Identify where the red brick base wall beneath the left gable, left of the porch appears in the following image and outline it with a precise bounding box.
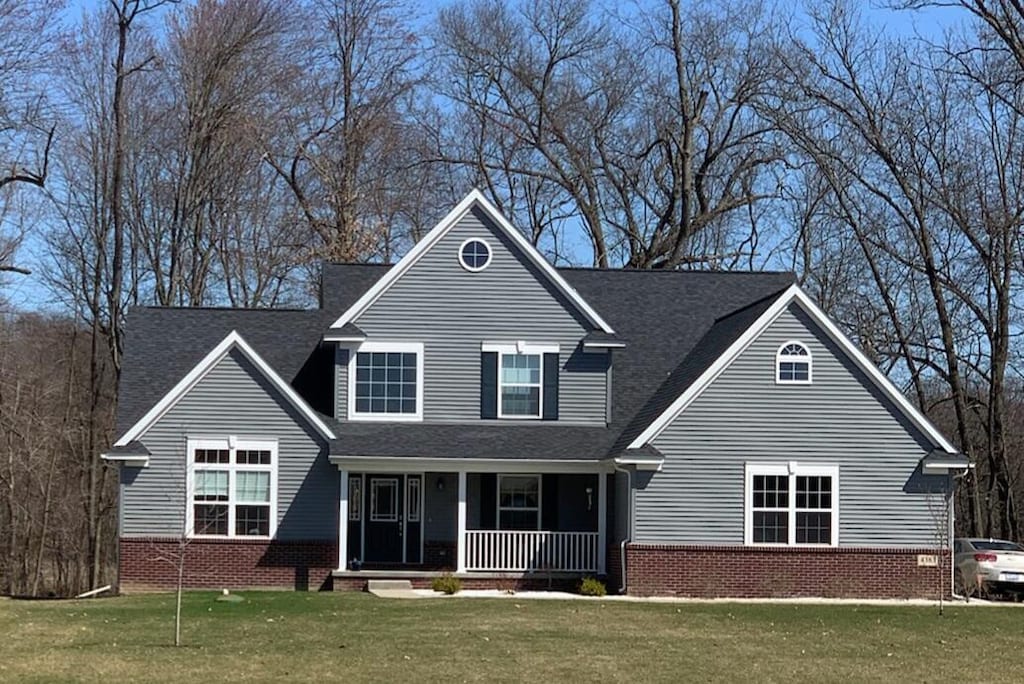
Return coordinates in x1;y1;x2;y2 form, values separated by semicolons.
119;538;338;592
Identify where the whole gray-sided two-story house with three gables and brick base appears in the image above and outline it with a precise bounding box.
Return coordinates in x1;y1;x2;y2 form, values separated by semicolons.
103;191;967;596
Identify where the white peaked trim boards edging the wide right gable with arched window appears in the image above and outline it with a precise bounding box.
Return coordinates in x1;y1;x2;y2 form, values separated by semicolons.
627;285;958;454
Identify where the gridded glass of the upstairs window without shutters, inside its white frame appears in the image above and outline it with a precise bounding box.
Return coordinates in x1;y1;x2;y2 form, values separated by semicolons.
355;351;417;414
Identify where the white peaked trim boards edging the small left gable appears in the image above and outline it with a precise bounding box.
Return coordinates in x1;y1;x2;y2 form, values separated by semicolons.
114;330;335;446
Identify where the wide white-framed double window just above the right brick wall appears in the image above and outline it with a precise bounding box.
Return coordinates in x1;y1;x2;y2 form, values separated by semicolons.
743;461;839;546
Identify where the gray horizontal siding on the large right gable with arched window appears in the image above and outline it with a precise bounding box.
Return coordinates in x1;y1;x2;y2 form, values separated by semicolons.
635;305;938;547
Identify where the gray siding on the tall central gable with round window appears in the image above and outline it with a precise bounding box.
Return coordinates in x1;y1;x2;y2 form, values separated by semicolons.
336;205;608;424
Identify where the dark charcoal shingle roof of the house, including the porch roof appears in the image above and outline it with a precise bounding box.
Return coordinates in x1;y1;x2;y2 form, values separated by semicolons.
118;263;794;459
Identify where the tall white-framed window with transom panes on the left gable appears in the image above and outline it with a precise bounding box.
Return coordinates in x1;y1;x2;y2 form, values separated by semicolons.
186;437;278;539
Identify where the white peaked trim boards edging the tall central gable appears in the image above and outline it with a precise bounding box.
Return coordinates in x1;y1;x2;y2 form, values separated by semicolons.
331;188;615;333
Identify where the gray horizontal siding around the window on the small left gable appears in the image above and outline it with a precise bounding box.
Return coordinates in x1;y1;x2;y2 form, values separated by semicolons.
121;350;340;541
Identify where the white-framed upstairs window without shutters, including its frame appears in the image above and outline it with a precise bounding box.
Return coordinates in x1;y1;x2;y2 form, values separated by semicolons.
348;342;423;421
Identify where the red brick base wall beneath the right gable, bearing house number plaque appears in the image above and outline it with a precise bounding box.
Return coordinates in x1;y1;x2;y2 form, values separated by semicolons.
622;544;949;598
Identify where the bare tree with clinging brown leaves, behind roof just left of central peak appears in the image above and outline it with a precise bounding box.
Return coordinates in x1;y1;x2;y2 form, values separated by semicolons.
265;0;422;261
